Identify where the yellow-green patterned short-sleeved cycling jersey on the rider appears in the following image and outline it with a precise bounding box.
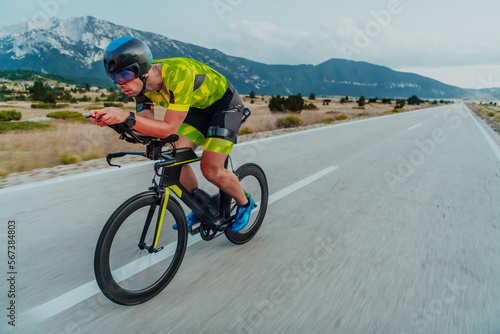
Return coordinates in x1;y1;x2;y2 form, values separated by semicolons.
142;58;228;112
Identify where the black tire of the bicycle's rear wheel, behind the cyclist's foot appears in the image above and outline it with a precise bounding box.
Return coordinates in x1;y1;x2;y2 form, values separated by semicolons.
224;163;269;245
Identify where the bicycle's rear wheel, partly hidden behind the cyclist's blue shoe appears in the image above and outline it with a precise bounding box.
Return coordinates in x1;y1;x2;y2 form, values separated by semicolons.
224;163;269;245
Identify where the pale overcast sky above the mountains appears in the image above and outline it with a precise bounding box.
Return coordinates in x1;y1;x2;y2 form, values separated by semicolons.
0;0;500;88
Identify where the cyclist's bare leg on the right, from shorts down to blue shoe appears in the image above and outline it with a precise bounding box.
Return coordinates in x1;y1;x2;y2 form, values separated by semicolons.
200;151;248;205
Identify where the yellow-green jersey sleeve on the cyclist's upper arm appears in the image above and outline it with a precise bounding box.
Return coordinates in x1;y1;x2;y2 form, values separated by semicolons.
162;63;196;111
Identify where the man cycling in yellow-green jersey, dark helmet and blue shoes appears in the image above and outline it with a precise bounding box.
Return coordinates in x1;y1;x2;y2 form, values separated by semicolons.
90;36;254;232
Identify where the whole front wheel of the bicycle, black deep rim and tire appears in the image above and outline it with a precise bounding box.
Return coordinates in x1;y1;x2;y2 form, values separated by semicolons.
94;191;187;305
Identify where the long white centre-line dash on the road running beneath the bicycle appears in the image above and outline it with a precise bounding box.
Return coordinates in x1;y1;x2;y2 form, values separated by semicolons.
23;166;338;324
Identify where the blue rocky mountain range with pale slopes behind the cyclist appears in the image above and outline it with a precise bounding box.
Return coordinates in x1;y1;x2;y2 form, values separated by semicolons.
0;16;494;99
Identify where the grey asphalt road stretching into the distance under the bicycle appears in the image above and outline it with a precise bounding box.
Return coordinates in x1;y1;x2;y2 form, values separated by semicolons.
0;103;500;334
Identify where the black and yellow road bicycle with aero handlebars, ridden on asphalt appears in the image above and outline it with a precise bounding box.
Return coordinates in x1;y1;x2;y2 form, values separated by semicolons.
94;109;268;305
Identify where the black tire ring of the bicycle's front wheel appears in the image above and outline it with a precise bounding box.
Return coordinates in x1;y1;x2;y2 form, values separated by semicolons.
94;191;188;306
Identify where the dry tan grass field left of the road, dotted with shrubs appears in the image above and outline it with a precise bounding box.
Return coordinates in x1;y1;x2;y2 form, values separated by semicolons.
0;93;444;177
